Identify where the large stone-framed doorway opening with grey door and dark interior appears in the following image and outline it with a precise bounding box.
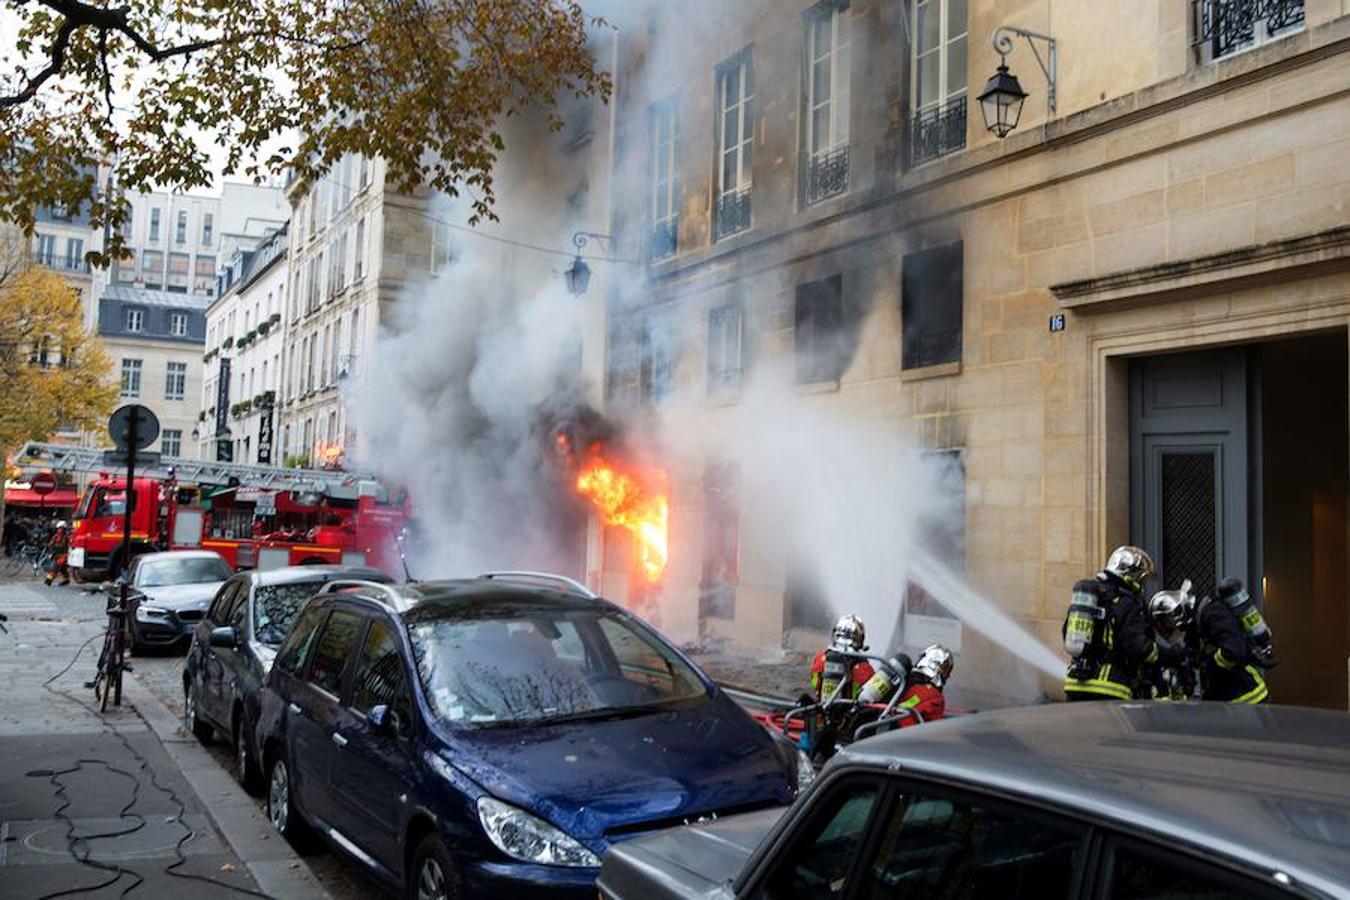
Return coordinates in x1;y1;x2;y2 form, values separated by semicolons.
1130;331;1350;710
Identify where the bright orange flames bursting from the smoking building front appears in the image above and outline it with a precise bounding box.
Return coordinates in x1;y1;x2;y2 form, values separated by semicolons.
576;453;670;583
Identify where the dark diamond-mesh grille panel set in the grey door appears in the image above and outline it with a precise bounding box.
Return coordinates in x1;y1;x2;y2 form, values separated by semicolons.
1161;453;1219;596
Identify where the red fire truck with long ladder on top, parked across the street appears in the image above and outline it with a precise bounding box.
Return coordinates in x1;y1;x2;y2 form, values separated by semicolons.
16;443;409;582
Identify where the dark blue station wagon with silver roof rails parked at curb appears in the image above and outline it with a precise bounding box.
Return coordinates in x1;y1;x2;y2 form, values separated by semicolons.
258;573;811;900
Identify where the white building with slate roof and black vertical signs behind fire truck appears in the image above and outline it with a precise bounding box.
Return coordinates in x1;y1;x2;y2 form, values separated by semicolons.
193;225;289;466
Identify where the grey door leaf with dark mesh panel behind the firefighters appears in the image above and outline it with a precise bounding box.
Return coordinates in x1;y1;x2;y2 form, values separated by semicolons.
1130;348;1251;594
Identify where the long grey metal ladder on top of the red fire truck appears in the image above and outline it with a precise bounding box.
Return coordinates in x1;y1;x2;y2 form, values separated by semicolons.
14;441;379;499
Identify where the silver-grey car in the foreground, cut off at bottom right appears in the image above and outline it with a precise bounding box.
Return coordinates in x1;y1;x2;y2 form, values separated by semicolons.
598;703;1350;900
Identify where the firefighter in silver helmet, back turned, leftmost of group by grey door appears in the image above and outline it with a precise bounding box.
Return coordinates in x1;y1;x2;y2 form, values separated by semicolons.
1064;546;1184;702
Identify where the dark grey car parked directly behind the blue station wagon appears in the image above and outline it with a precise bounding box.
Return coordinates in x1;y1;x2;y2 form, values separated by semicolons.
182;565;390;787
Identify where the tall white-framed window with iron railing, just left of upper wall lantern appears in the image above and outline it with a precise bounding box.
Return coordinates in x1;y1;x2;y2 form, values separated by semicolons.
909;0;968;165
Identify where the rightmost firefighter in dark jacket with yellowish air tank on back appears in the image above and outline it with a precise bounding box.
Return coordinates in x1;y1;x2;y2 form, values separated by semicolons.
1193;579;1273;703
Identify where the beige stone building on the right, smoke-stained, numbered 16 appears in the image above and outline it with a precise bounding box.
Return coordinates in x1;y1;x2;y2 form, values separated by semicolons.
599;0;1350;708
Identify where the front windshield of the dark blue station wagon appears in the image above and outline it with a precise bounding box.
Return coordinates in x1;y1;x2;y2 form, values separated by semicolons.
408;607;707;727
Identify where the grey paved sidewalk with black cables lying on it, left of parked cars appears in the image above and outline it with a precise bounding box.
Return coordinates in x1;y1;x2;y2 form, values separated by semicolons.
0;580;327;900
